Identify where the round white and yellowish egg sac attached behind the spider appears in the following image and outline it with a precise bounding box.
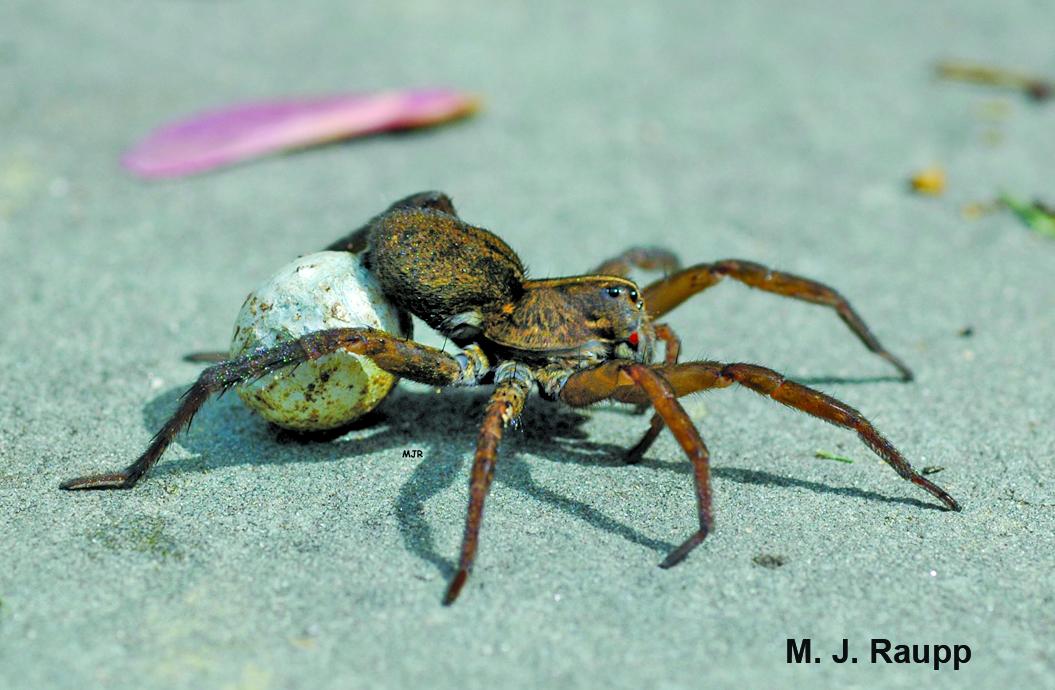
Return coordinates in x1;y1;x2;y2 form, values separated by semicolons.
231;251;410;430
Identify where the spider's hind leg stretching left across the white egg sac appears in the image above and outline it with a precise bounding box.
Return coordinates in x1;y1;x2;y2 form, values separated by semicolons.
61;328;487;490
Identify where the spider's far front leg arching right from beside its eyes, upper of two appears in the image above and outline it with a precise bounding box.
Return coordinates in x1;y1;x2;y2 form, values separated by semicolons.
642;260;913;381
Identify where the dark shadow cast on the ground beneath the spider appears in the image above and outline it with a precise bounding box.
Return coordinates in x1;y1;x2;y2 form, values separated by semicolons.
143;386;937;578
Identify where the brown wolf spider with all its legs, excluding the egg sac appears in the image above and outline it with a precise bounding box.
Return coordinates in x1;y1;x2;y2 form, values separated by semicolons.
62;192;960;605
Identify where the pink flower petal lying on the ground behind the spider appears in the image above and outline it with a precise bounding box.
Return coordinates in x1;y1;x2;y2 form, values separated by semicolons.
121;89;479;178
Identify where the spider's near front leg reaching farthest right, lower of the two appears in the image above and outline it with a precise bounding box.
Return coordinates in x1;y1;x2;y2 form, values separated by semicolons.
560;361;960;511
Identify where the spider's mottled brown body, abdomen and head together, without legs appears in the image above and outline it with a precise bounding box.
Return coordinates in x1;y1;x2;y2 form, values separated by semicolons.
366;208;652;368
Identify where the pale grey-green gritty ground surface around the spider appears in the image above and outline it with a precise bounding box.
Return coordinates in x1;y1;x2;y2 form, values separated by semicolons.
0;0;1055;689
